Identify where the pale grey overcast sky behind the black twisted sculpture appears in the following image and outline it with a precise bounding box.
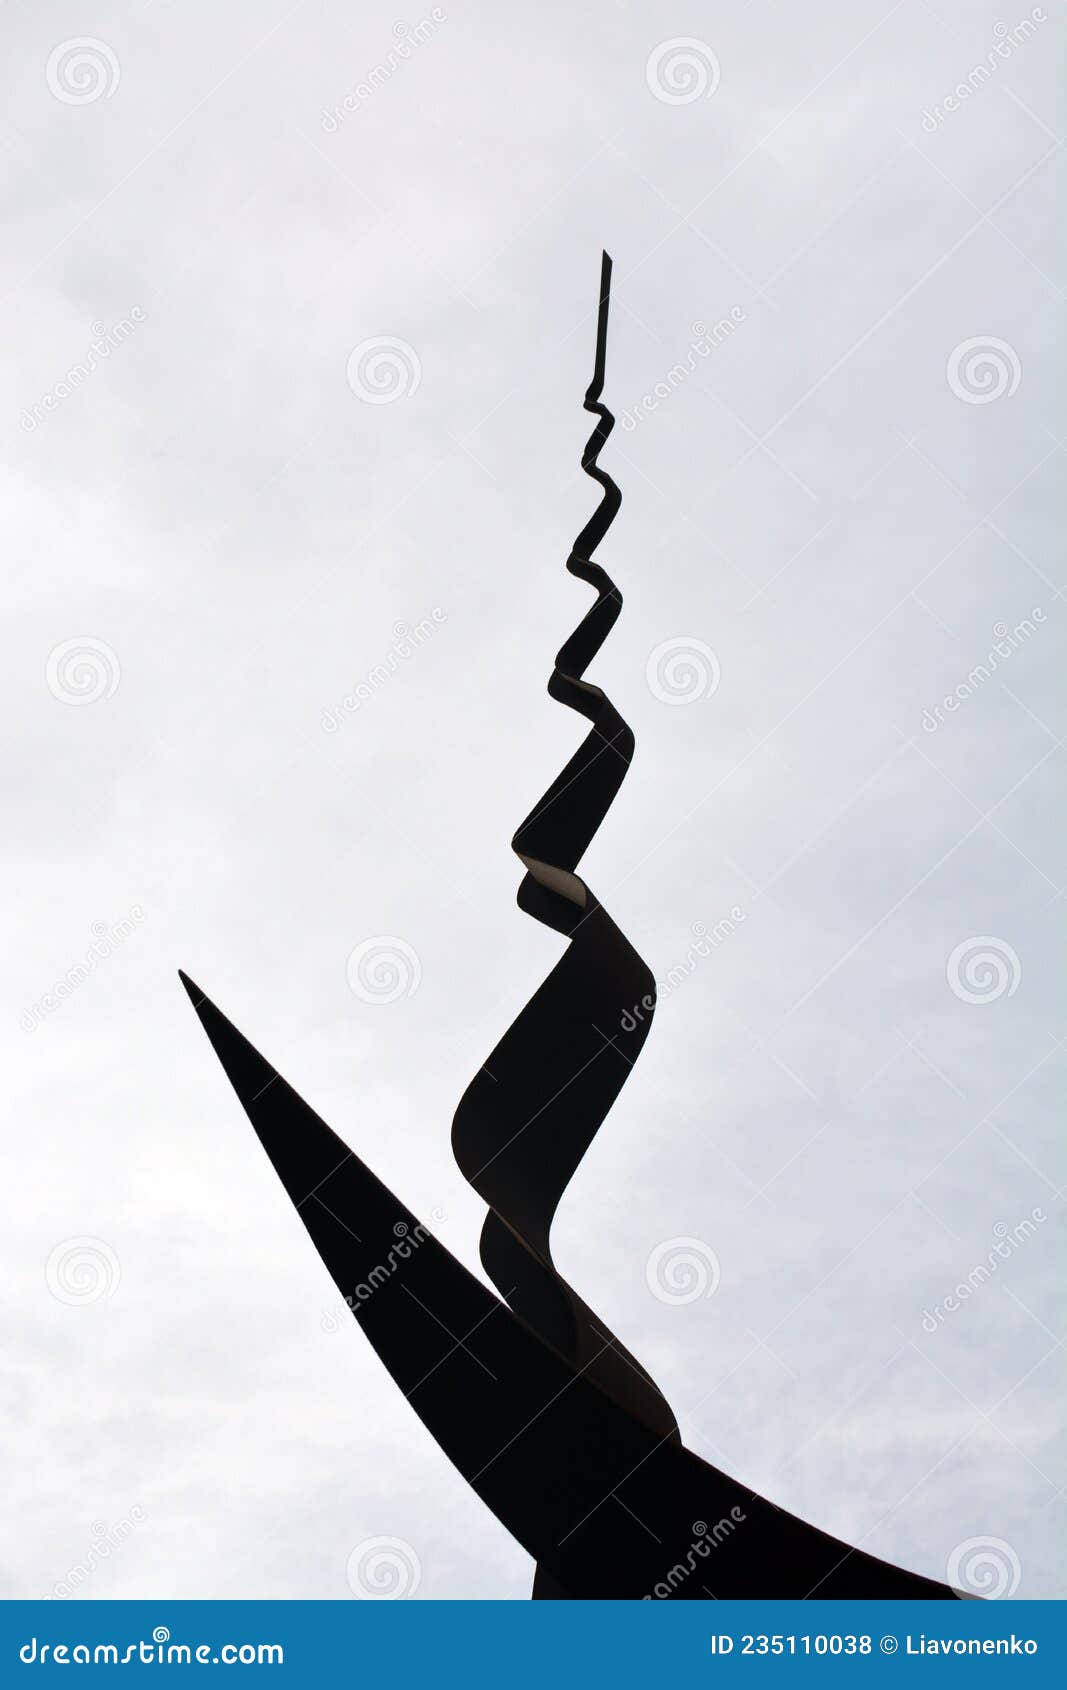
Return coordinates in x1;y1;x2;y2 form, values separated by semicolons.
0;0;1067;1599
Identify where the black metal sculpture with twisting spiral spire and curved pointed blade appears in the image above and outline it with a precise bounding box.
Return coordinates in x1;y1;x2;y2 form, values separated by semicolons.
181;254;955;1599
